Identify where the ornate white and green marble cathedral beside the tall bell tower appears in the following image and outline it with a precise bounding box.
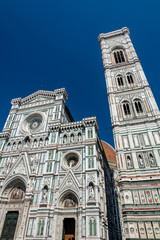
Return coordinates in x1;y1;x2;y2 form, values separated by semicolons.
0;89;120;240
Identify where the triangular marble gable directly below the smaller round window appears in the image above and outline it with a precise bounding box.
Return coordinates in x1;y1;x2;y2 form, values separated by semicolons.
59;169;81;194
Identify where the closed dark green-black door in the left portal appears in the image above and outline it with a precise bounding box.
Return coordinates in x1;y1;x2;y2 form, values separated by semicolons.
0;212;19;240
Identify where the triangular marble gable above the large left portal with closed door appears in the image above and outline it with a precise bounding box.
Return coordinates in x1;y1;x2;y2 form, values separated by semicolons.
6;153;30;179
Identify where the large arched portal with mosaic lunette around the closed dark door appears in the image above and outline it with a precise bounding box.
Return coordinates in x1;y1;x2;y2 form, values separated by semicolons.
0;179;26;240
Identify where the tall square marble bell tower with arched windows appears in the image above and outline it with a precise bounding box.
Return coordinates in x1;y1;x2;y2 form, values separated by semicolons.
98;27;160;239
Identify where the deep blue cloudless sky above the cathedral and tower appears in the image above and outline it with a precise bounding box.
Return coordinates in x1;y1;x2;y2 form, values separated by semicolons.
0;0;160;146
